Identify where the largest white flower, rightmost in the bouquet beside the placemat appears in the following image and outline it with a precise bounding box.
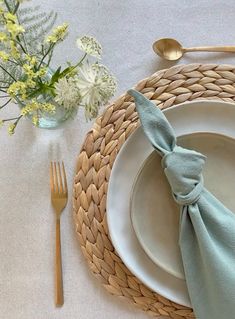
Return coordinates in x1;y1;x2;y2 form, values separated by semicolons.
76;63;117;119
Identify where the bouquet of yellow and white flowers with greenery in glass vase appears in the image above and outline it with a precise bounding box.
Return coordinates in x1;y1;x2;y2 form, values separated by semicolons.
0;0;116;134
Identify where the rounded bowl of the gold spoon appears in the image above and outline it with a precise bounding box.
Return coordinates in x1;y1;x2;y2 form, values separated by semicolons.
153;38;184;61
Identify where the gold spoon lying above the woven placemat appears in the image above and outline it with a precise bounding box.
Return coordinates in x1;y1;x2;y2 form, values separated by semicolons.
153;38;235;61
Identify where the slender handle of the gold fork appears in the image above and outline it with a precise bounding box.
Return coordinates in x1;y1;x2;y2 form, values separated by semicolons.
55;217;64;307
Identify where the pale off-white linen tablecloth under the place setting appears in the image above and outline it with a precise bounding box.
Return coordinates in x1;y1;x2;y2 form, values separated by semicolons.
0;0;235;319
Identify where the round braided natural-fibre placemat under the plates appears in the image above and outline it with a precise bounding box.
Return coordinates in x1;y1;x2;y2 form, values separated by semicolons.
73;64;235;319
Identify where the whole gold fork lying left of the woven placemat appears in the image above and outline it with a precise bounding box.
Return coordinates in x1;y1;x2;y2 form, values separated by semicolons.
50;162;68;307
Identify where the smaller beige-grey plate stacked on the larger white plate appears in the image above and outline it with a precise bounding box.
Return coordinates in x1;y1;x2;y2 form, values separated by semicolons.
130;133;235;279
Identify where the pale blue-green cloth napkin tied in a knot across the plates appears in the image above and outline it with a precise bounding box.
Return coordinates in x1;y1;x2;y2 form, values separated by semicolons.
128;90;235;319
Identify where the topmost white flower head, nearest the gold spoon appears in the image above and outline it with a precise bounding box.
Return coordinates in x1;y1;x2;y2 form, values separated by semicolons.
77;35;102;58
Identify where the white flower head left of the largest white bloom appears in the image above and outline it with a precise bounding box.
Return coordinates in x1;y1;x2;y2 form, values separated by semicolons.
55;77;80;109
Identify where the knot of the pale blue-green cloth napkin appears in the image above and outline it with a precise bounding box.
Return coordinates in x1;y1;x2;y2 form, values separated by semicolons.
162;146;205;205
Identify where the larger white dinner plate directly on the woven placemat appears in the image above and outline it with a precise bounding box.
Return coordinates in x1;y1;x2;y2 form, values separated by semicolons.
107;101;235;307
